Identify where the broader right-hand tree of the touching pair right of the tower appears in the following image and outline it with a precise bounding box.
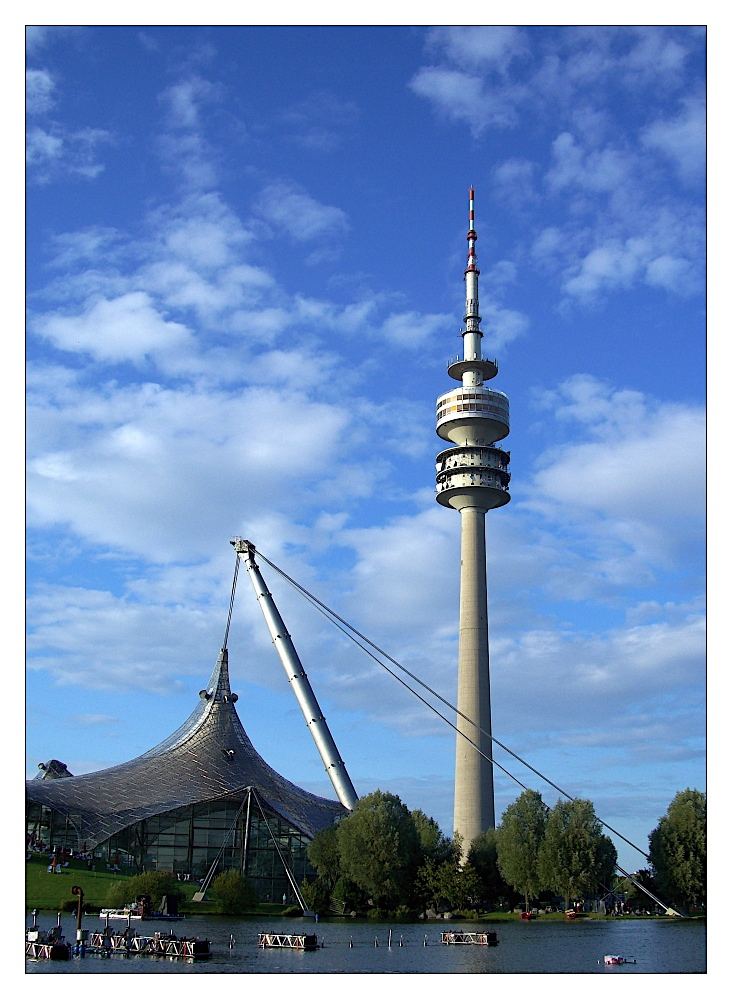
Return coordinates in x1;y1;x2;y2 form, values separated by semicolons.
536;799;617;906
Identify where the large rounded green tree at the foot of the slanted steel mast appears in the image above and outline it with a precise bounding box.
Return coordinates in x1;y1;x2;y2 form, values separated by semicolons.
336;791;420;909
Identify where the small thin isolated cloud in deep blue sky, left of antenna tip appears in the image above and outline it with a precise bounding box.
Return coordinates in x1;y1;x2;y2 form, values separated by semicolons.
255;182;348;243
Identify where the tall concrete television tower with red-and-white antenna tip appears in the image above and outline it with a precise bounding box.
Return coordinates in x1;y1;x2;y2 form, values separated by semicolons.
436;188;511;856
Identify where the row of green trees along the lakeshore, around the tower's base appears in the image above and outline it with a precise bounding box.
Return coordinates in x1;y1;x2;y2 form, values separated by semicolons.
302;789;706;917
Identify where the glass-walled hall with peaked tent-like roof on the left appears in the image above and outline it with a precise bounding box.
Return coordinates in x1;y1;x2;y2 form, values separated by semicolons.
26;649;346;902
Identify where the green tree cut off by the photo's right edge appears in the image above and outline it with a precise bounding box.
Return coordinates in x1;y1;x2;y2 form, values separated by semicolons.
648;788;707;909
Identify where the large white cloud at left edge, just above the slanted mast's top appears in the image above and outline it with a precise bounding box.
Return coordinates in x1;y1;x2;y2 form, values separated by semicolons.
29;370;362;561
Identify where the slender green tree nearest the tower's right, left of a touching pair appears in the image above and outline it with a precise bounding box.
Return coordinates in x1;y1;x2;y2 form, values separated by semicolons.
496;789;546;910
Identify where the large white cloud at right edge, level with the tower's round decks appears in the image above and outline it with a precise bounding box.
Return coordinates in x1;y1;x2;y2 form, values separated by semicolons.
526;376;706;575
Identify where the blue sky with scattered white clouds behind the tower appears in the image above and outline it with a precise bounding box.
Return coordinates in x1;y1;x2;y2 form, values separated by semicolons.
25;19;707;870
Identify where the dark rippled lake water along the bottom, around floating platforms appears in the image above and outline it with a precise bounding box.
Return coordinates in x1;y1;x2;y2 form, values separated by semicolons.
26;913;706;976
